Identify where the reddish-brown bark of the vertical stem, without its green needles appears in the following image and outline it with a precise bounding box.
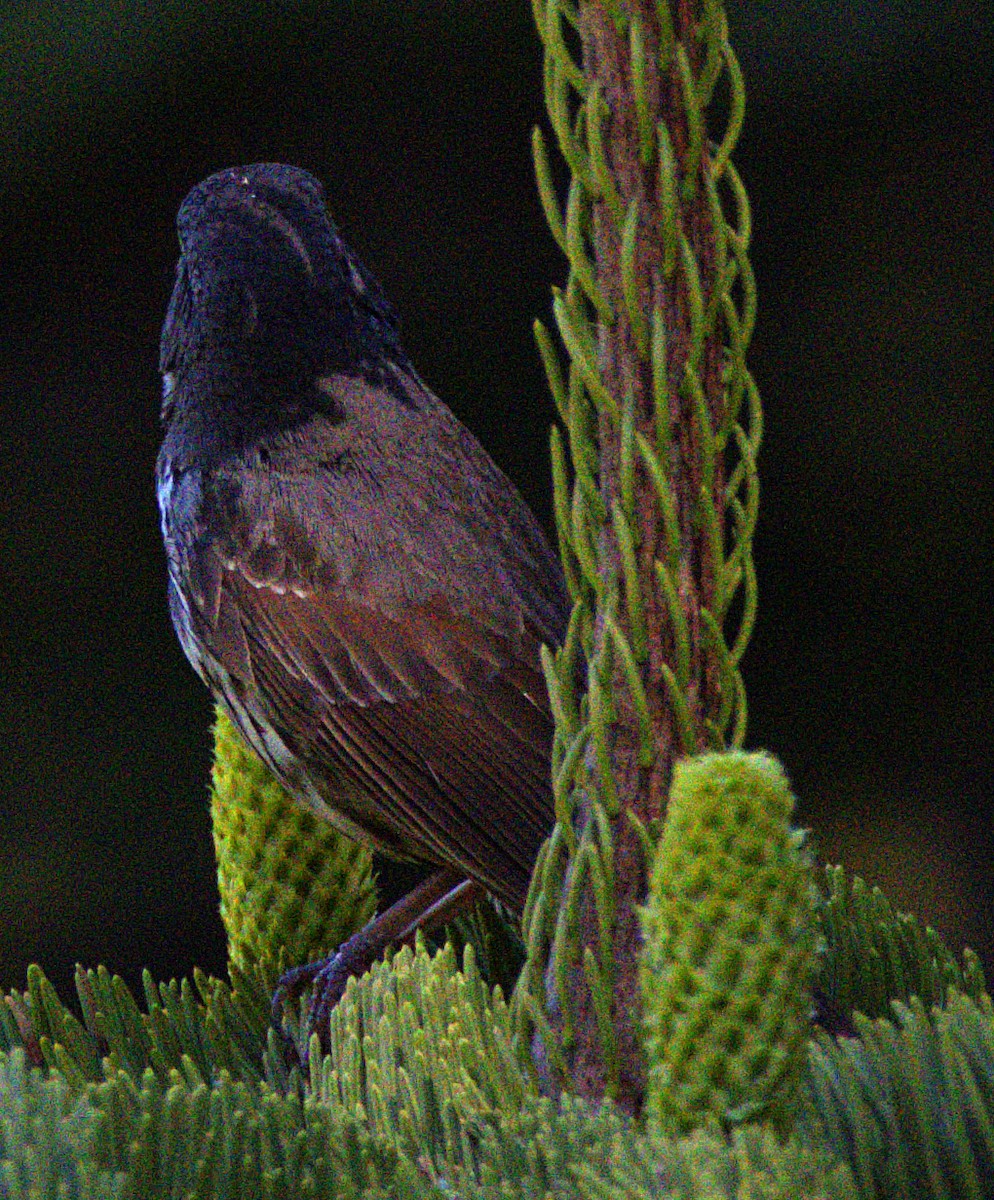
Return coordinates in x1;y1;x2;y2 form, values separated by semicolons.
561;0;724;1111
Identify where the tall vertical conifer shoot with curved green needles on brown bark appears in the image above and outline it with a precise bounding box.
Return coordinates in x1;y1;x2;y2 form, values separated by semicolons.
514;0;762;1111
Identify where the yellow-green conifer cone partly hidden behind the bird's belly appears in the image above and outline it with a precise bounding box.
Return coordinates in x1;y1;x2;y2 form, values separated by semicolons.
210;708;376;967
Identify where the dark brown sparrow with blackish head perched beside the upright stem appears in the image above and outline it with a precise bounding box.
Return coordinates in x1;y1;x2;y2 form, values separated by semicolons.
157;163;568;1036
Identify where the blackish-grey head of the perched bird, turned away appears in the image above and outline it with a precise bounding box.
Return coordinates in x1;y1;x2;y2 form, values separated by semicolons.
160;163;402;373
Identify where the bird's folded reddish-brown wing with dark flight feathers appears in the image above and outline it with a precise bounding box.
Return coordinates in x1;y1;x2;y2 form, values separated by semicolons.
180;525;552;910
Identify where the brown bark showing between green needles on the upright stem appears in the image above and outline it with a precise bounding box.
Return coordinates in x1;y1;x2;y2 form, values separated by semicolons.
549;0;724;1114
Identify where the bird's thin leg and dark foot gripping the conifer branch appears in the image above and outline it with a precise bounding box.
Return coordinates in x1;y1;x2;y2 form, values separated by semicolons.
271;868;486;1061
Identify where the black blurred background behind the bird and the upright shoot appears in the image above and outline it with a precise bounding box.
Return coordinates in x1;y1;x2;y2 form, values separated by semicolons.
0;0;994;989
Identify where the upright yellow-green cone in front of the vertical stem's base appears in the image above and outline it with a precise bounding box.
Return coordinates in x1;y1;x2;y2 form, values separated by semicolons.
641;751;816;1133
